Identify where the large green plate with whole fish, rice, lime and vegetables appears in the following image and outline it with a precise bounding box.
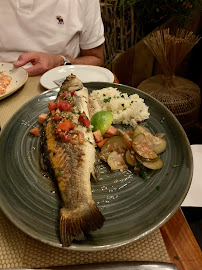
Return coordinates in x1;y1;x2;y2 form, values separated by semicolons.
0;75;193;251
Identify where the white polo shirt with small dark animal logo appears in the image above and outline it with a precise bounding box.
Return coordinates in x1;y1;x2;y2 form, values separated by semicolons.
0;0;105;62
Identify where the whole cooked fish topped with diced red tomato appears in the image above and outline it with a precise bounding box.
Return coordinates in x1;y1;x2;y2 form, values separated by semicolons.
41;75;104;246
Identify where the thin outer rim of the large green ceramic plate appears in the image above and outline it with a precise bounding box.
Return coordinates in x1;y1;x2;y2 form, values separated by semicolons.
0;82;193;251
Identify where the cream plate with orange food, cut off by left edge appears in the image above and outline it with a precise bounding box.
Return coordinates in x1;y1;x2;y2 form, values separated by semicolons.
0;62;28;100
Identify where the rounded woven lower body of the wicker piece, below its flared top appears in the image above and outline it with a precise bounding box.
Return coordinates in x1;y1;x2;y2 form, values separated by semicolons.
137;75;201;130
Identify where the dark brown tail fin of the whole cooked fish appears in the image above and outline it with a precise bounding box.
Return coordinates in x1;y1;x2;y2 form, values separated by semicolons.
60;200;105;247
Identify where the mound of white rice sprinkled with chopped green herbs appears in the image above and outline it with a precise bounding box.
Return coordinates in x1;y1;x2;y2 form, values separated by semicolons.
90;87;150;127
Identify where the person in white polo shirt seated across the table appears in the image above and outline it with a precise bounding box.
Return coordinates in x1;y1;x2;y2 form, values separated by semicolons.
0;0;105;76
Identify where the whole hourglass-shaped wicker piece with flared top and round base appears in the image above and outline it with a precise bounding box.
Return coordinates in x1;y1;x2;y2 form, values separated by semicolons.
137;29;201;129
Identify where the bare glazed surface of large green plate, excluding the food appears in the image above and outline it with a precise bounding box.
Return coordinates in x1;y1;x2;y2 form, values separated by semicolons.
0;82;193;250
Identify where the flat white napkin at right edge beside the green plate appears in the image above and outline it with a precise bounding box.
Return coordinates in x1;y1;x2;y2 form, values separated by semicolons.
181;144;202;207
